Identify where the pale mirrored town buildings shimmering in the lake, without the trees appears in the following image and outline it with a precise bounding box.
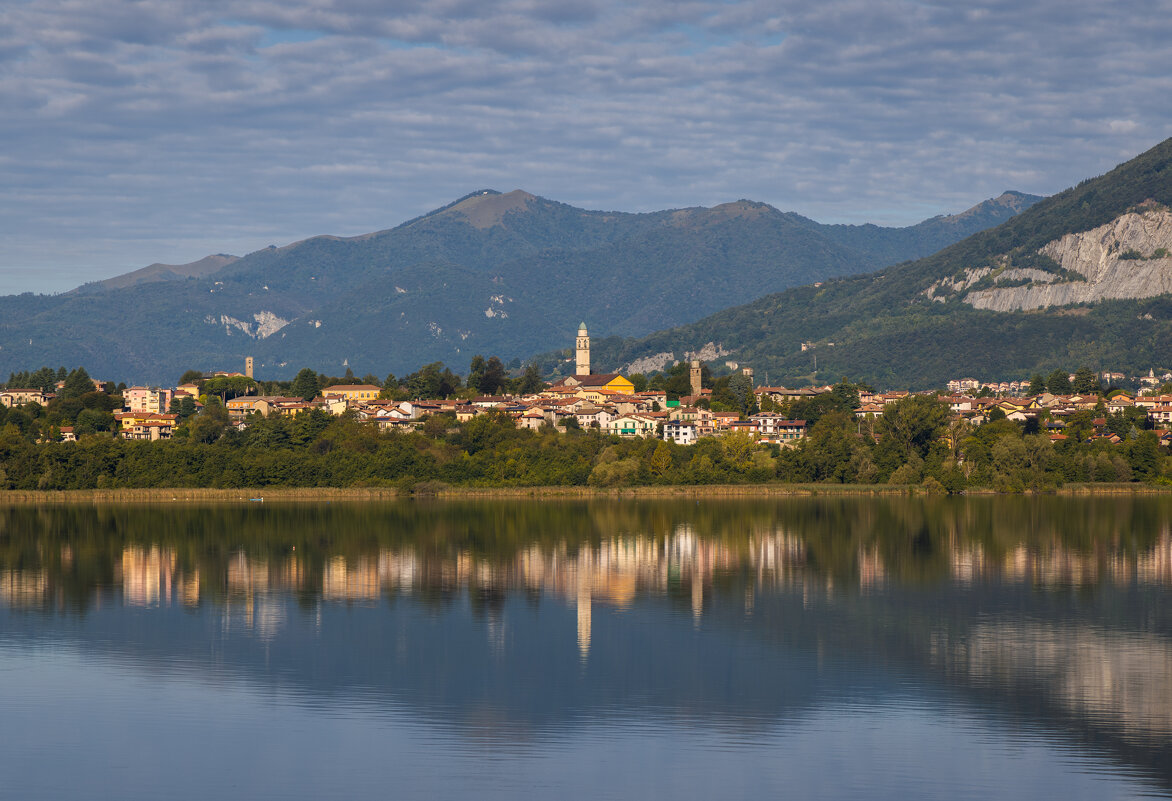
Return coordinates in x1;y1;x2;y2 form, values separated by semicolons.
0;524;1172;617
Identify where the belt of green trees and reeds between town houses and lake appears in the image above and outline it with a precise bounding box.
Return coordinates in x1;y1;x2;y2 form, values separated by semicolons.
0;375;1172;494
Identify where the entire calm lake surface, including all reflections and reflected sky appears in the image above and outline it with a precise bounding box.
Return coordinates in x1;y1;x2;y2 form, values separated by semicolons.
0;497;1172;800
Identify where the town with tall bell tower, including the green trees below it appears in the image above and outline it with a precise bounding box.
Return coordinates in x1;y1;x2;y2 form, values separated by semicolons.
0;324;1172;493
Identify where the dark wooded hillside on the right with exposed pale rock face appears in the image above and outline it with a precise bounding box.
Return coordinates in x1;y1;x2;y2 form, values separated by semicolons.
578;140;1172;388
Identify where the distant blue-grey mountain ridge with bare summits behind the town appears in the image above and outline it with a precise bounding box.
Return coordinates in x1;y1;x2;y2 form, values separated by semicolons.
0;190;1037;381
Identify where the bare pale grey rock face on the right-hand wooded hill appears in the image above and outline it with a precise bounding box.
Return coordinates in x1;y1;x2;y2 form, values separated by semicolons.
965;208;1172;312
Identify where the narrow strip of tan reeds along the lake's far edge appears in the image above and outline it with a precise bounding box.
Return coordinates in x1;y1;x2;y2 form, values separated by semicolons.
0;483;1172;508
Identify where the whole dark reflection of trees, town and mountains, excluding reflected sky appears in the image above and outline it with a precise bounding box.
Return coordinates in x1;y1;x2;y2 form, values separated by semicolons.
0;497;1172;794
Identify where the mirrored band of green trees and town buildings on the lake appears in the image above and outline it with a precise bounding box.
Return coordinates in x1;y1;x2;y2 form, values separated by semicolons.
0;498;1172;616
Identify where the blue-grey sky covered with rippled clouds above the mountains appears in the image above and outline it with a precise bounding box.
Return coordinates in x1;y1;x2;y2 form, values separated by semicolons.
0;0;1172;294
